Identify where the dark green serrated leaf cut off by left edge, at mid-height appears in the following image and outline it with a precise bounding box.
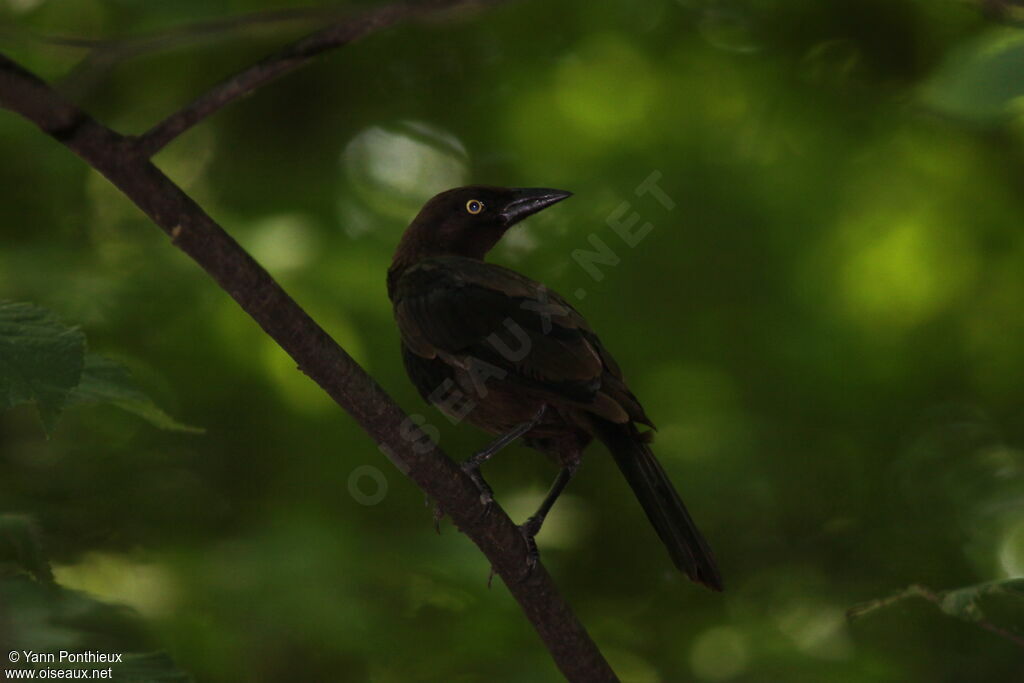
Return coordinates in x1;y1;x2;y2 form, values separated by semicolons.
0;302;85;436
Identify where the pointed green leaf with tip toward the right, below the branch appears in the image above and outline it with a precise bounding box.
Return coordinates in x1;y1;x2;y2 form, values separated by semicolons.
70;353;204;433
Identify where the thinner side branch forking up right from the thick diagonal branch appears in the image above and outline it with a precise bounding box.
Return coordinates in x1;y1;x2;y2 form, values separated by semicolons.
137;0;498;157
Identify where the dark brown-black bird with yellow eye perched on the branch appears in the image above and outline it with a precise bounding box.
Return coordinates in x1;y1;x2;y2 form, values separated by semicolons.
387;185;723;591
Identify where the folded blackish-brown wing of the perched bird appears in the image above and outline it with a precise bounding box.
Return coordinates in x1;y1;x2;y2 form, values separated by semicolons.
394;256;649;423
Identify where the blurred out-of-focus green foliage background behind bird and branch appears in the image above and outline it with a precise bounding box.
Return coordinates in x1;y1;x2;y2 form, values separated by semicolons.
0;0;1024;683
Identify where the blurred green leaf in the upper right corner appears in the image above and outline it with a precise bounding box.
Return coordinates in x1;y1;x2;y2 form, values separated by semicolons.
921;29;1024;124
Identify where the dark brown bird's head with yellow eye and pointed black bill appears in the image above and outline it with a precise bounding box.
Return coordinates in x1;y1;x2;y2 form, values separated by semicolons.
395;185;572;261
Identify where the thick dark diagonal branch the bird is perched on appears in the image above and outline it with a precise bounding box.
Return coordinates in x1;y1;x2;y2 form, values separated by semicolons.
0;52;617;683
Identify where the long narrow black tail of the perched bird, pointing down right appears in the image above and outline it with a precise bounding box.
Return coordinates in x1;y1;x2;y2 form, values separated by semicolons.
597;420;722;591
